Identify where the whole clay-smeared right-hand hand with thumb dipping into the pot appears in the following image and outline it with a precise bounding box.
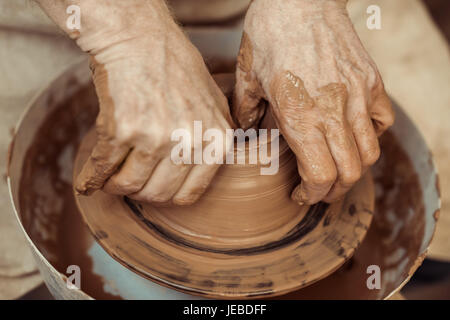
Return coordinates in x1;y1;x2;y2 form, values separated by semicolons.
233;0;394;204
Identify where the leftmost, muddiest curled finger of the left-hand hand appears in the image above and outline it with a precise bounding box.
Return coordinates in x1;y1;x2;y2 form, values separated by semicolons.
75;133;130;195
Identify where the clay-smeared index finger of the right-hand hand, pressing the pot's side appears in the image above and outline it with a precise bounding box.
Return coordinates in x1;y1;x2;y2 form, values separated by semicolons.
271;72;337;205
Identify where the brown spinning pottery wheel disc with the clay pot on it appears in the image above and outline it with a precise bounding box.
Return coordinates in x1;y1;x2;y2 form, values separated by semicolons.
74;124;374;298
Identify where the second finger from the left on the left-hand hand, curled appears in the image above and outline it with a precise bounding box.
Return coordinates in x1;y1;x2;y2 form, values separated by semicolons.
103;149;160;195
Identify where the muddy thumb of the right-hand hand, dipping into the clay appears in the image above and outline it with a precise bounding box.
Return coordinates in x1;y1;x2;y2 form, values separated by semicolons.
232;32;264;129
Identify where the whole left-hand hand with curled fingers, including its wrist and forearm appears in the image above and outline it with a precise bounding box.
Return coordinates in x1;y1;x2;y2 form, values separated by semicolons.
39;0;232;205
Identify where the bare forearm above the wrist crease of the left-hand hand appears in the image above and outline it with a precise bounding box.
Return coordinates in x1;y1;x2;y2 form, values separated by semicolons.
36;0;177;53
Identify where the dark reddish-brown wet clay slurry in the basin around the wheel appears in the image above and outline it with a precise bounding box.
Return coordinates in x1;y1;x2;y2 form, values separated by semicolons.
19;79;424;299
